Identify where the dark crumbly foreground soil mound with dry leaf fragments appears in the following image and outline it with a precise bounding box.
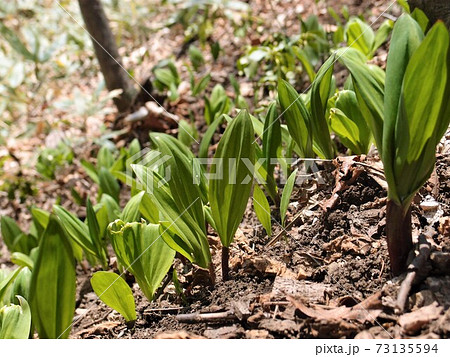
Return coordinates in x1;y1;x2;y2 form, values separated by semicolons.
72;158;450;338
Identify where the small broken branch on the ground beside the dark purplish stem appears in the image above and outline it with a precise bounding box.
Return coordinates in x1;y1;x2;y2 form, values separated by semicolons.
397;234;431;312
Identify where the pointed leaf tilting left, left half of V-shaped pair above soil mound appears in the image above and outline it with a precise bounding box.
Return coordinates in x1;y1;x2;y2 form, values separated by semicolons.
278;80;315;157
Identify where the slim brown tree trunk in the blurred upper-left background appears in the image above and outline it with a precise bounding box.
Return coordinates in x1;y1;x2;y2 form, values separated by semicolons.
78;0;137;112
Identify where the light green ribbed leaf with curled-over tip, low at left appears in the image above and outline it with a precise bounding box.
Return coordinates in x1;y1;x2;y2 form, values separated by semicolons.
109;220;175;301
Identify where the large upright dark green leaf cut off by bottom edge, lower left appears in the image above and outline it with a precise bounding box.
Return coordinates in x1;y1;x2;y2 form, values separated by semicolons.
30;216;76;339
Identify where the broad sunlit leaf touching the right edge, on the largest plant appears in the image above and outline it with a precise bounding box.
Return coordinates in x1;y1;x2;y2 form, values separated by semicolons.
394;23;450;204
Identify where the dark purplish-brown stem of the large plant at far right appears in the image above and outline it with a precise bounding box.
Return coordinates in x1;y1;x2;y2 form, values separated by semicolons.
386;200;413;276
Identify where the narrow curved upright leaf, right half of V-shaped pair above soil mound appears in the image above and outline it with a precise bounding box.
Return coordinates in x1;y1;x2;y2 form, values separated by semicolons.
311;55;335;159
